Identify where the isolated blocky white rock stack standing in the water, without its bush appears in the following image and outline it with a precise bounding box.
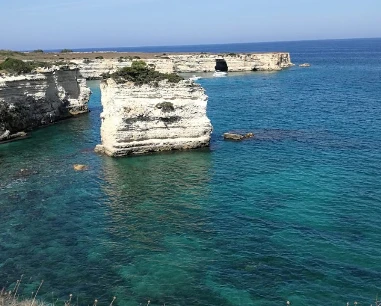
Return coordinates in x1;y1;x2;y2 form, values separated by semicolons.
96;79;212;156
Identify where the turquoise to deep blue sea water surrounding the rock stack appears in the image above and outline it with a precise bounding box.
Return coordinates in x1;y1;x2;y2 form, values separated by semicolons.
0;40;381;305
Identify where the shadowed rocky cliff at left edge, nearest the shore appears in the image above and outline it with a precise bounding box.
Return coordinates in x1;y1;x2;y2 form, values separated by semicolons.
0;67;90;141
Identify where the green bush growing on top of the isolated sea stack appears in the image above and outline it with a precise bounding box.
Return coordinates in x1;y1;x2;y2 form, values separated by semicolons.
103;61;183;86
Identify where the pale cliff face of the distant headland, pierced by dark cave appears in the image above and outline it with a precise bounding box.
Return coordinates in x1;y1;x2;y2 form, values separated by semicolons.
73;52;293;79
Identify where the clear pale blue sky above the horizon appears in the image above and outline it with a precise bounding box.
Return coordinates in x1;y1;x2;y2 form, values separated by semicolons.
0;0;381;50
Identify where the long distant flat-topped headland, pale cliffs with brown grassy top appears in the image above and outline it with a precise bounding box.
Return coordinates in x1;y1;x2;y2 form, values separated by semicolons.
0;52;293;79
